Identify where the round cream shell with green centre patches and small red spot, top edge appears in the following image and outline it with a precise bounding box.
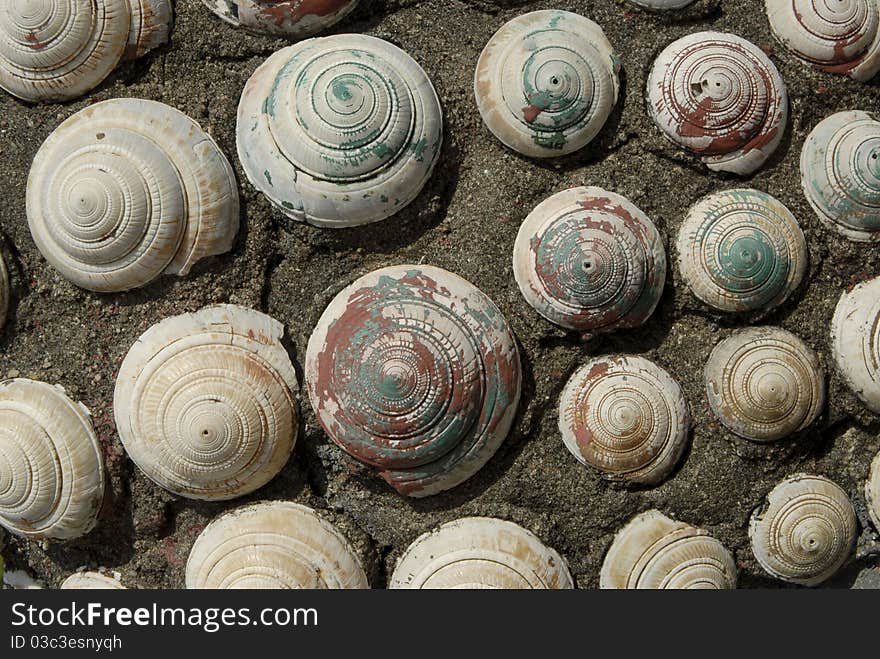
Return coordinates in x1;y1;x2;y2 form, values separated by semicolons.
474;10;620;158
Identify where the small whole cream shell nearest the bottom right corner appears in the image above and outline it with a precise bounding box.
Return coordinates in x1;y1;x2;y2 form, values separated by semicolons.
749;474;857;586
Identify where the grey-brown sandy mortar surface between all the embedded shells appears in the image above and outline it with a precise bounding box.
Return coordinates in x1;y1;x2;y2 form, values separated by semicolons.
0;0;880;587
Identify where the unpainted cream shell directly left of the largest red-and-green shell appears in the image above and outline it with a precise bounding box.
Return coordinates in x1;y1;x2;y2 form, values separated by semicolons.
114;304;298;500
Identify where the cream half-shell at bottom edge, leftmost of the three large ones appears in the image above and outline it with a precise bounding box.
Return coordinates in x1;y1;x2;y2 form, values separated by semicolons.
186;501;370;590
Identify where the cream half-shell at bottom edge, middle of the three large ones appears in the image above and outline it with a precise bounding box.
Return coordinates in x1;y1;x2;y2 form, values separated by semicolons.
388;517;574;590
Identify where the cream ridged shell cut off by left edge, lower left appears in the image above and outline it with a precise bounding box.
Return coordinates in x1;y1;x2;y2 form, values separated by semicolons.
0;379;104;540
